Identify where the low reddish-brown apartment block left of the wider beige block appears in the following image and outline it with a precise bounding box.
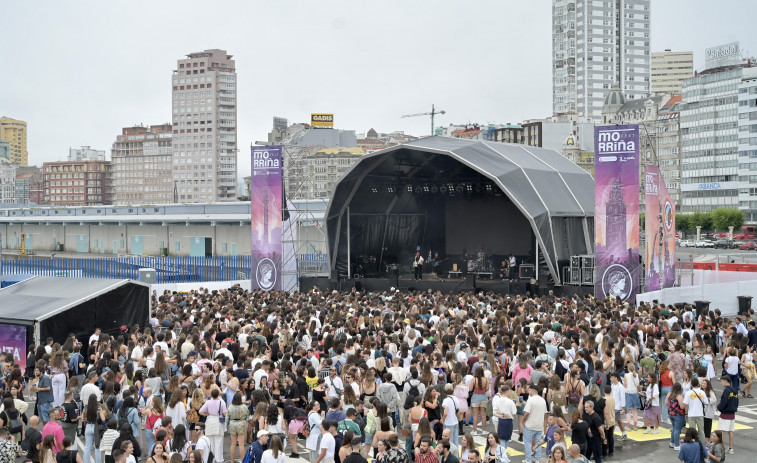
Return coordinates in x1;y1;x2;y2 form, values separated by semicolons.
42;161;113;206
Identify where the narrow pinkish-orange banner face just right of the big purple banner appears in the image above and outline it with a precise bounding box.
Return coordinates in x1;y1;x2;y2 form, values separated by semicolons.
644;165;662;291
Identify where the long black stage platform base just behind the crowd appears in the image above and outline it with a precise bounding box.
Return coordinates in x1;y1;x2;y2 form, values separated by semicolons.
300;274;594;296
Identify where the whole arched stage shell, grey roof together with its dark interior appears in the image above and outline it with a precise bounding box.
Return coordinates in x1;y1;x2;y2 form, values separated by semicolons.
326;137;594;284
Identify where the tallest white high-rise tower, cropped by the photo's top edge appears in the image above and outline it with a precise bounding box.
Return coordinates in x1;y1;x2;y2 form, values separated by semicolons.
552;0;651;122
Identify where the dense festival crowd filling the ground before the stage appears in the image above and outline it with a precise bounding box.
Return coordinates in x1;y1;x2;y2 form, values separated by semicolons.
0;286;757;463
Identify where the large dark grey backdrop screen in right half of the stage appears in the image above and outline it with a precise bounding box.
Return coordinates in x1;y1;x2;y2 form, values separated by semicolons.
446;197;534;256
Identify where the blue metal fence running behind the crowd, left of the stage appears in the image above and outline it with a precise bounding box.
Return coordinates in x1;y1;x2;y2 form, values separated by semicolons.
0;254;329;283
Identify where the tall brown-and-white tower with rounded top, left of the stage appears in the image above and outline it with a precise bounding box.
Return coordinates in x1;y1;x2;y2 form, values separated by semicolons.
172;49;237;203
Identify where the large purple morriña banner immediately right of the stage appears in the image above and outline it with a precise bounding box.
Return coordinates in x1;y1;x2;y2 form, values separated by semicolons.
594;125;640;303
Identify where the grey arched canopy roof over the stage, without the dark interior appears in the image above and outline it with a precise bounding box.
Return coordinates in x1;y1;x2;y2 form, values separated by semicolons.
326;137;594;284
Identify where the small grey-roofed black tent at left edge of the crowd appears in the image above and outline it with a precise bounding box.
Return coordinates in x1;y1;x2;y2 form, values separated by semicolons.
0;276;150;343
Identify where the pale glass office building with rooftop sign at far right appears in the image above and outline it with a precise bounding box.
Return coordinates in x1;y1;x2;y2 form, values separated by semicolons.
680;43;757;216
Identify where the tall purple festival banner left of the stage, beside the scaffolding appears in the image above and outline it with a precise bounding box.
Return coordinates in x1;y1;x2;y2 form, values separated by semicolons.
250;146;283;291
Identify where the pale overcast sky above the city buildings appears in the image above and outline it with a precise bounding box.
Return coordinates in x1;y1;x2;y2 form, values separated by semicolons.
0;0;757;182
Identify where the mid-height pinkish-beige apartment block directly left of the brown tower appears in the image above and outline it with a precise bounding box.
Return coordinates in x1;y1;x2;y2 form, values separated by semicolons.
111;124;174;205
